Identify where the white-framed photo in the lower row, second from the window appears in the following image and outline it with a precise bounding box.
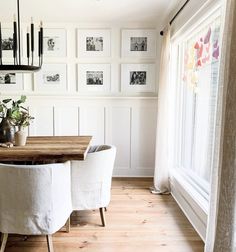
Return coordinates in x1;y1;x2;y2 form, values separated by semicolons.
78;64;111;92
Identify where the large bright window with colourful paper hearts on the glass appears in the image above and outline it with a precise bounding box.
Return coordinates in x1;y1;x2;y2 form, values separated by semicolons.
174;8;221;190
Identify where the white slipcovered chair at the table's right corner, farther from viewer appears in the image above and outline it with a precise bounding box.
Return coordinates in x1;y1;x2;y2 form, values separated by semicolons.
71;145;116;226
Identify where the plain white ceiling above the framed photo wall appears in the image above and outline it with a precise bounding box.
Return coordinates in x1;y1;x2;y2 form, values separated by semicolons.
0;0;181;23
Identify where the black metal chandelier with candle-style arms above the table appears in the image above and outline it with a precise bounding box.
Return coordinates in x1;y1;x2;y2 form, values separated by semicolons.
0;0;43;73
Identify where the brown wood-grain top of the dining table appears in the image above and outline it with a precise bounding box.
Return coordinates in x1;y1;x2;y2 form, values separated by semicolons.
0;136;92;162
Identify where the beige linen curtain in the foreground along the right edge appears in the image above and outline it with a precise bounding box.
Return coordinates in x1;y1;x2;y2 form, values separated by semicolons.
205;0;236;252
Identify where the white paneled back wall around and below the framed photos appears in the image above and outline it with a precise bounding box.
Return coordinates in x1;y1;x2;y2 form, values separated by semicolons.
0;23;159;176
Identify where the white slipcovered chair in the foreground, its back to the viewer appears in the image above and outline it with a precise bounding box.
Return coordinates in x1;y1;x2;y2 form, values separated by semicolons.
0;162;72;252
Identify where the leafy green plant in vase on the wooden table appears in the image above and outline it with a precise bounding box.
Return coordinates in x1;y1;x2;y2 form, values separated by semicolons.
0;95;34;146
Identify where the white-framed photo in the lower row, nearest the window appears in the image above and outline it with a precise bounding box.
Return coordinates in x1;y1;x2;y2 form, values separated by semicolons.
121;64;156;92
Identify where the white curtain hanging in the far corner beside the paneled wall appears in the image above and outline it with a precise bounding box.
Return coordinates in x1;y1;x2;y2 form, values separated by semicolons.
152;26;170;194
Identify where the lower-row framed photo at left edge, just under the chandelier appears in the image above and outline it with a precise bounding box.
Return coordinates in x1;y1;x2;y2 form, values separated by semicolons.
0;73;23;91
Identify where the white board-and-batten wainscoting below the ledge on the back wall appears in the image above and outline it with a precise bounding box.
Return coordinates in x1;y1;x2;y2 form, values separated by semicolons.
25;96;157;176
